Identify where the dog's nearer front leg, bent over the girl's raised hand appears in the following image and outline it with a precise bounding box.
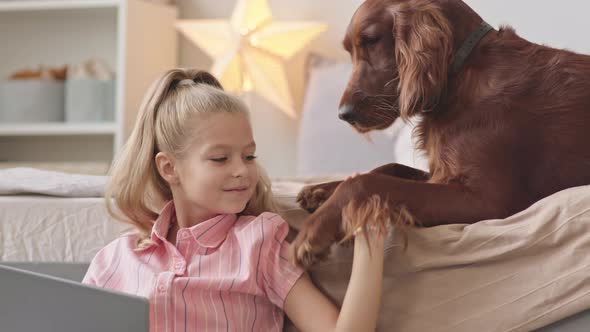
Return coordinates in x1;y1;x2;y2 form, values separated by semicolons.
293;173;515;267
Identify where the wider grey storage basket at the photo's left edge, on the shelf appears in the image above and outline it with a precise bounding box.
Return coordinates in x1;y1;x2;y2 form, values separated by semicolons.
0;80;64;123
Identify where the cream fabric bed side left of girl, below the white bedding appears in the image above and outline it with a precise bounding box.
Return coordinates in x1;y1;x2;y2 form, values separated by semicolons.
0;195;130;262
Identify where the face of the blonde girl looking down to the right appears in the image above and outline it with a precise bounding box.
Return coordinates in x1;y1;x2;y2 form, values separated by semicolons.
175;112;258;218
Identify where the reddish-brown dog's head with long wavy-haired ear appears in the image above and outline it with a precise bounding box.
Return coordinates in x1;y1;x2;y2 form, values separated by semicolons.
338;0;453;132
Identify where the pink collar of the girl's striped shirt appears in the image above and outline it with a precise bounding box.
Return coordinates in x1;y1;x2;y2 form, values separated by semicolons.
151;201;237;248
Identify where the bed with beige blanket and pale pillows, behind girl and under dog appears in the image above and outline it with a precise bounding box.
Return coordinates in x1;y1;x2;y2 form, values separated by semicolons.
0;63;590;332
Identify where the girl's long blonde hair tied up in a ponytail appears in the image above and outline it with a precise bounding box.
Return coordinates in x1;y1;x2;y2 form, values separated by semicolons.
105;69;277;247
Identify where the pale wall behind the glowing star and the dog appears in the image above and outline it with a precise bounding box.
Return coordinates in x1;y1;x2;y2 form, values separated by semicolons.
177;0;590;176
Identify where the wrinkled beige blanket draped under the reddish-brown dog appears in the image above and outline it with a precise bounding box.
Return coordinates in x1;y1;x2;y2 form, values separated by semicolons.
283;186;590;332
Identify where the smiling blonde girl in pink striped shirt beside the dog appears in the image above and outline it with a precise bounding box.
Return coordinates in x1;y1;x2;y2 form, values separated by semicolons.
83;69;385;332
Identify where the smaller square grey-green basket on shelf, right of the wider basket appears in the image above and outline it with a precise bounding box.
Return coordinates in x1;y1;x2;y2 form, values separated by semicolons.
65;79;115;122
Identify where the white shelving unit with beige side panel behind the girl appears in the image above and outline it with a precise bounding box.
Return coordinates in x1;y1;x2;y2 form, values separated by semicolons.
0;0;178;174
